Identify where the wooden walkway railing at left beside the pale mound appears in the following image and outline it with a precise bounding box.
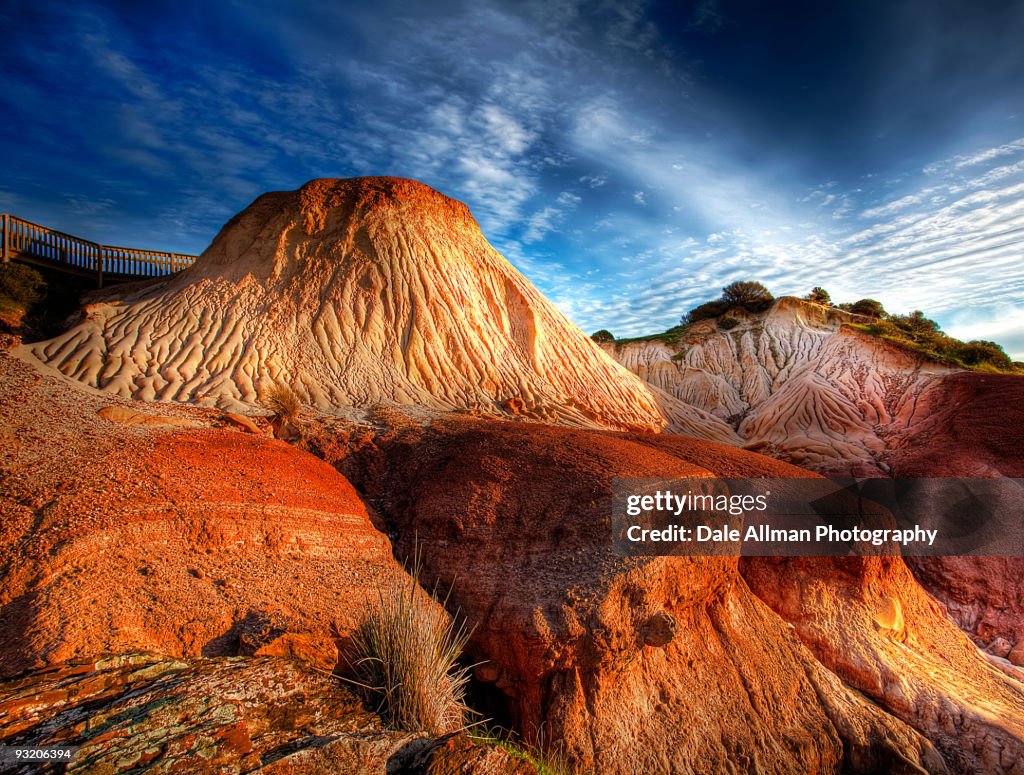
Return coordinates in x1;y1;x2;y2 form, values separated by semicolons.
0;213;196;288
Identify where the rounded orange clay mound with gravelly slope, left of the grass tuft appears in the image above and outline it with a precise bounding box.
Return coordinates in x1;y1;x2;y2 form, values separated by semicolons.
0;343;417;676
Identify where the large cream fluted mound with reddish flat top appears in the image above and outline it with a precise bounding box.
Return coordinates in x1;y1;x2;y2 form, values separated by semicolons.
32;178;735;441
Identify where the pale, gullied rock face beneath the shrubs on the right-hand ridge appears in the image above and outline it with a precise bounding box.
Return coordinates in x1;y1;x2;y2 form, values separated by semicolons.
605;298;954;475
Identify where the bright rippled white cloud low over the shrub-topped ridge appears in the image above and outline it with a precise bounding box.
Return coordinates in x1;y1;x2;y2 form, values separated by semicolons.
561;136;1024;348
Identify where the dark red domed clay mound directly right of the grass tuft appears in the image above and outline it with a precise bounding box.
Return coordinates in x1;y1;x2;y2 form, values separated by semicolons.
325;418;952;773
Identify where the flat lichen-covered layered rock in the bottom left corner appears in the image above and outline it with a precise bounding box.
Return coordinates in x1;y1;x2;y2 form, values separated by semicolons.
0;654;432;775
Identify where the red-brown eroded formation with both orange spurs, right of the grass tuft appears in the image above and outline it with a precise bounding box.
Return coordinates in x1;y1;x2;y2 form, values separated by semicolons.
321;419;1024;773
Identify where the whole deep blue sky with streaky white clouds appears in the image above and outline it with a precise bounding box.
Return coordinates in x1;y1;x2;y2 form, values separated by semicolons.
0;0;1024;359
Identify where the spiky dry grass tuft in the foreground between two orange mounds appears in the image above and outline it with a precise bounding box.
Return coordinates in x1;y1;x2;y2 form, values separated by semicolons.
348;562;470;736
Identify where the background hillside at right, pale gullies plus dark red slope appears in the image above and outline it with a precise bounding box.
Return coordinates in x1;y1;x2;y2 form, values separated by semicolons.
605;309;1024;660
